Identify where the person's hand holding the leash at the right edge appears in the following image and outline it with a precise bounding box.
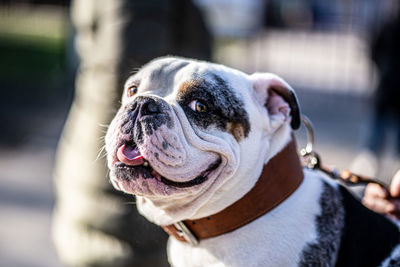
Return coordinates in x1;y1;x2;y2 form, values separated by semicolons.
362;170;400;220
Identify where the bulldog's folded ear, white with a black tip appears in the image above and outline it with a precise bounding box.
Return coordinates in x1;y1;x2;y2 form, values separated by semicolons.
250;73;300;130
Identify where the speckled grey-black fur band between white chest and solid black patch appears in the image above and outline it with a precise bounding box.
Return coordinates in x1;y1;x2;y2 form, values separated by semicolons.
299;183;345;266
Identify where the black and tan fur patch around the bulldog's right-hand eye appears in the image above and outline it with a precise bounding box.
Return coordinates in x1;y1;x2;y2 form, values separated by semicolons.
177;73;250;137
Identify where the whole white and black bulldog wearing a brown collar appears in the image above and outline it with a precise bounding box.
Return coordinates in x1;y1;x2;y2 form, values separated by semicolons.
106;57;400;267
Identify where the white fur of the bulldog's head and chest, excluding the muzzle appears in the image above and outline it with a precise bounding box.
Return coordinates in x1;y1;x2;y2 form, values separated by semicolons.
106;58;388;267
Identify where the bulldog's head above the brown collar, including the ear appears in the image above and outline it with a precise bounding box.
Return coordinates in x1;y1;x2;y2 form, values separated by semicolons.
106;57;300;224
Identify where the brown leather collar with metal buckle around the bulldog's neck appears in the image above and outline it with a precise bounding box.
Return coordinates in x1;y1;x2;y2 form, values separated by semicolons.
162;137;304;244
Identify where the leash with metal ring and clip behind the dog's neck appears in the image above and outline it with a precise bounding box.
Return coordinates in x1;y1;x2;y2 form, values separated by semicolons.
300;115;389;192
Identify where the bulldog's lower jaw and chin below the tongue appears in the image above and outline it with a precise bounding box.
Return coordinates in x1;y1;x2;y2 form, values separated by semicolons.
110;158;221;197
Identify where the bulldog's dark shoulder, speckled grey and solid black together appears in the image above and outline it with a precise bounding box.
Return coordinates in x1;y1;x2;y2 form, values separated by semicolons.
299;176;400;267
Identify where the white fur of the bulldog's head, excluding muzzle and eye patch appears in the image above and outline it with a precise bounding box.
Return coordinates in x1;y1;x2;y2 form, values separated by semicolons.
106;58;291;225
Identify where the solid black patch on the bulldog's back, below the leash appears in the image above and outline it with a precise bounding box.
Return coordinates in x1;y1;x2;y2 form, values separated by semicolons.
336;187;400;267
